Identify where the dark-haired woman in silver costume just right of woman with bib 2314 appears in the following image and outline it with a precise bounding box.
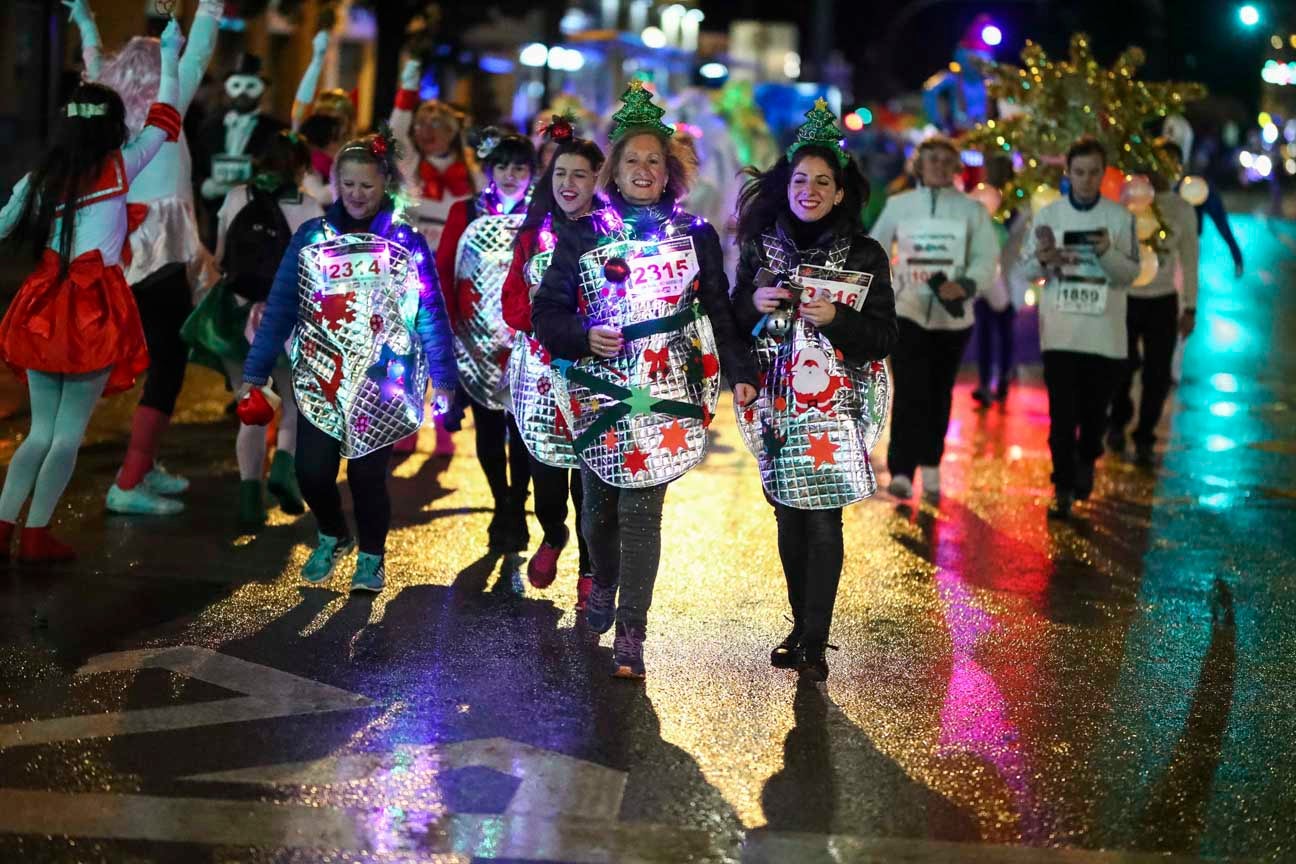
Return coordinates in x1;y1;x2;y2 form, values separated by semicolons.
437;128;535;552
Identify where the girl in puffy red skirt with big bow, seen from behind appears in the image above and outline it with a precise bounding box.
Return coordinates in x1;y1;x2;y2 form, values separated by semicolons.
0;21;183;561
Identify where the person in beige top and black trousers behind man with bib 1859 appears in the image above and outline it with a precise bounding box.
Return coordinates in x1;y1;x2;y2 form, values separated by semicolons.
1107;139;1199;468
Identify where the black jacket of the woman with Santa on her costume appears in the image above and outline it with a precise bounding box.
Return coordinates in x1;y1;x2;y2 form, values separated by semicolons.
734;220;899;363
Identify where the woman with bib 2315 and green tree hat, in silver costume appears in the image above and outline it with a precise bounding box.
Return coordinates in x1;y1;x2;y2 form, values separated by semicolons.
531;80;757;679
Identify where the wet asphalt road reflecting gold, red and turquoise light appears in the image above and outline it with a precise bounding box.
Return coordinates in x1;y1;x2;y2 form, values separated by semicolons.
0;219;1296;863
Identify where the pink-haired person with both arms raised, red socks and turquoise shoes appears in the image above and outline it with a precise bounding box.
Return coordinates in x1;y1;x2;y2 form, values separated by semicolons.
66;0;222;514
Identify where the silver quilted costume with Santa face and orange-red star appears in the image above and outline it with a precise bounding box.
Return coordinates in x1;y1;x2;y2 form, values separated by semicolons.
735;231;890;510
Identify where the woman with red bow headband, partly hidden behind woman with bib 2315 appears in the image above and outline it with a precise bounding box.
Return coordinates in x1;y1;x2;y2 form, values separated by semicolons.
503;114;603;610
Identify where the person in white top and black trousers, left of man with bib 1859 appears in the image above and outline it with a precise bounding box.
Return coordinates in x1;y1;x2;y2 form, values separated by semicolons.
870;136;999;503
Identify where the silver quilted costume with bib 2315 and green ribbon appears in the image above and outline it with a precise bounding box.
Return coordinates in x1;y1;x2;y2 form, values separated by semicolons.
555;214;719;488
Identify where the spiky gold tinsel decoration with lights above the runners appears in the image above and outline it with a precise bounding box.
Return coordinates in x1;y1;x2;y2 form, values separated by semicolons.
963;34;1207;229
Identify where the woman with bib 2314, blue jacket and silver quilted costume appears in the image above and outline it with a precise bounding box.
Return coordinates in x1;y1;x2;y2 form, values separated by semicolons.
238;132;455;592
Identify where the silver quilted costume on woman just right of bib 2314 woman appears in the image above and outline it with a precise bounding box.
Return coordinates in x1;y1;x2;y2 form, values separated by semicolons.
443;214;525;411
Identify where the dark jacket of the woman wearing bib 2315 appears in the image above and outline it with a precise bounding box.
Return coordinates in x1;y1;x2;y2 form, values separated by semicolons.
531;198;757;386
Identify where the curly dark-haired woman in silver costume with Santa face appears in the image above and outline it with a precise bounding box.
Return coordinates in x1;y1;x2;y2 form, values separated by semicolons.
734;100;898;681
